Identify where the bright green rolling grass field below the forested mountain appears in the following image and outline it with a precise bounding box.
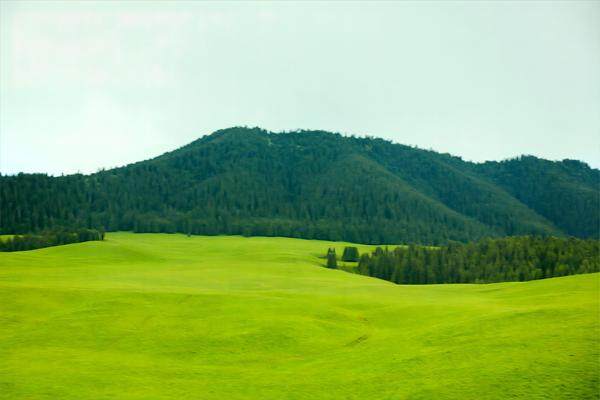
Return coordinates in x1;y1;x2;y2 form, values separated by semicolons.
0;233;600;400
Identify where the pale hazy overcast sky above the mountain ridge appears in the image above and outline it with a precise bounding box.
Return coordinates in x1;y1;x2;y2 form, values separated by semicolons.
0;1;600;174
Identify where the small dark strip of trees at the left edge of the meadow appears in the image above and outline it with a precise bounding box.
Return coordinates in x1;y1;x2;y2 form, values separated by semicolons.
0;228;104;251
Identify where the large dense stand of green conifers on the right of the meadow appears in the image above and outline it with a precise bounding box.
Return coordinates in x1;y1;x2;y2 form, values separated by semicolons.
357;236;600;284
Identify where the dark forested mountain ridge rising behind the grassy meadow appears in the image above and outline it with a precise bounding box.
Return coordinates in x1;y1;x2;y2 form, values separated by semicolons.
0;128;600;244
